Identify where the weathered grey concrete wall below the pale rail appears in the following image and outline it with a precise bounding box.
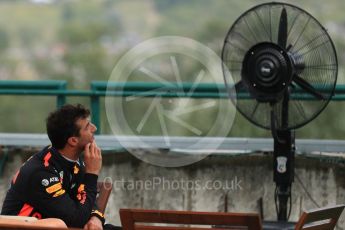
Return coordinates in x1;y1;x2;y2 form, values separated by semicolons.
0;151;345;229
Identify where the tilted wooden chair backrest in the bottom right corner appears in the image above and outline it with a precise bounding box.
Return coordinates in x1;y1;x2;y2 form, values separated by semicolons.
295;204;345;230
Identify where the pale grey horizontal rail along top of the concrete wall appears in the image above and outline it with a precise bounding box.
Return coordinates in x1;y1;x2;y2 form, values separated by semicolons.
0;133;345;157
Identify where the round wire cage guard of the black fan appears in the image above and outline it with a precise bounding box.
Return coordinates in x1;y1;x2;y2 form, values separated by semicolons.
222;2;338;130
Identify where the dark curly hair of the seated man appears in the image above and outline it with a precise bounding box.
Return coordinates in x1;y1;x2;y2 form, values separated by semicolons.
47;104;90;149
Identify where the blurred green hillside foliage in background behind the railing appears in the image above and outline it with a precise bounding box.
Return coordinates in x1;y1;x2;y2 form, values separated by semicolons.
0;0;345;139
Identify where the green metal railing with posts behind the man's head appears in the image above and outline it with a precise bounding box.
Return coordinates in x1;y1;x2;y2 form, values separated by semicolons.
0;81;345;134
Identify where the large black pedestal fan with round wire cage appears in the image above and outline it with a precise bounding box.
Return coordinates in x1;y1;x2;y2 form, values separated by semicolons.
222;2;338;221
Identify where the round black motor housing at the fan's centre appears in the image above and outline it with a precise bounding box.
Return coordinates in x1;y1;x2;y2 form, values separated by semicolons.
242;42;293;103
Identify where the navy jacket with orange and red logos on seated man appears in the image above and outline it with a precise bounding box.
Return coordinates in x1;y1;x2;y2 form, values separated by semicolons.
1;146;104;228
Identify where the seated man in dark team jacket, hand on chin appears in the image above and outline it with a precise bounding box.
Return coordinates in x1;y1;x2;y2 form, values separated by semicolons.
1;105;118;229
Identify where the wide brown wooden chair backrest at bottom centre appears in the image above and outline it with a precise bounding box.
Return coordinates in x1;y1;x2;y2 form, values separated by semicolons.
120;209;262;230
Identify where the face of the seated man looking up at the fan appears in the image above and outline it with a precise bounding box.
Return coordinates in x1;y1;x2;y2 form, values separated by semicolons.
77;118;97;151
